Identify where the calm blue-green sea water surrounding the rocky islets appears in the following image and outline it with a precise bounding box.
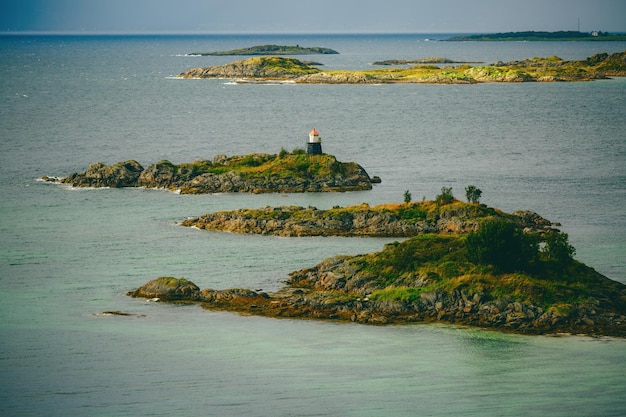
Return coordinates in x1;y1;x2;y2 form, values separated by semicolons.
0;34;626;417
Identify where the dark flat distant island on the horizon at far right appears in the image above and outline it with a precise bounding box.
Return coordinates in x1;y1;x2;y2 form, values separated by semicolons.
444;30;626;41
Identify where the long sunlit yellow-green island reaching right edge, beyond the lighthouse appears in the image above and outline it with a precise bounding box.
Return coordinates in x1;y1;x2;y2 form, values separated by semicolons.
178;51;626;84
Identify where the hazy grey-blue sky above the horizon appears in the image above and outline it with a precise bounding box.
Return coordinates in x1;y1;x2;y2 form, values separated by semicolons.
0;0;626;33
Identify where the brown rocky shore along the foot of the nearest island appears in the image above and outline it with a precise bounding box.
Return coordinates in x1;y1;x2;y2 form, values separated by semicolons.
128;264;626;337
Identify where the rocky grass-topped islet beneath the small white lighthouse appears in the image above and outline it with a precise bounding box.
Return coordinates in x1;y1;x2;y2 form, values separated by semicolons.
42;149;378;194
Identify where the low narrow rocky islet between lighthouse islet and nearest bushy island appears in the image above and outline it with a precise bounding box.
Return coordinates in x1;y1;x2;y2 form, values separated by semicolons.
181;201;558;237
